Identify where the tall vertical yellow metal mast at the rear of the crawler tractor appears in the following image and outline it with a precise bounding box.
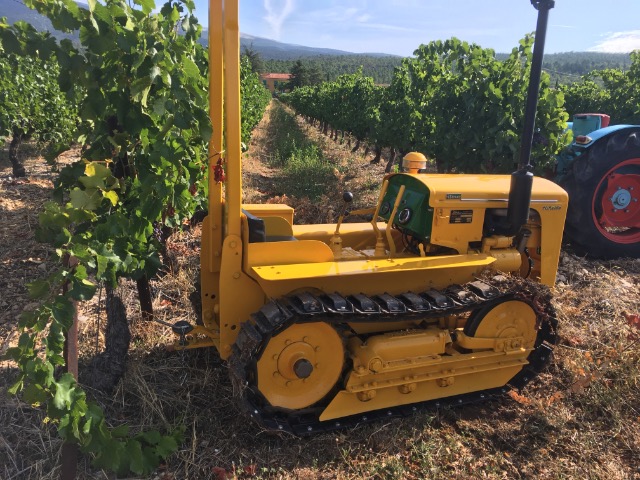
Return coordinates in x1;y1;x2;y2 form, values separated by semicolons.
200;0;242;335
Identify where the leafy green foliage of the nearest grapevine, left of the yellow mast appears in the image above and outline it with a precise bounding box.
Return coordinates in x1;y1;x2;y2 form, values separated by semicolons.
0;0;268;474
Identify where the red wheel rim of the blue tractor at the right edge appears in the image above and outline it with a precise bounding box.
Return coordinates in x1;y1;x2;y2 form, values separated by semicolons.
591;158;640;244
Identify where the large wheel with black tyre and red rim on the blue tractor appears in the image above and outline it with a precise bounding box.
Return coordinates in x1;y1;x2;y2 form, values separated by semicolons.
560;128;640;259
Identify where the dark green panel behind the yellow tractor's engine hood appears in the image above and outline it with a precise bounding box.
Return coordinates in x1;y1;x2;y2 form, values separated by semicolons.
380;173;433;242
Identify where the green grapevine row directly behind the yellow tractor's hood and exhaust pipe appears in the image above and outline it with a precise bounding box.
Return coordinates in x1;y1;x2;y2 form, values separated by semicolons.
284;36;567;172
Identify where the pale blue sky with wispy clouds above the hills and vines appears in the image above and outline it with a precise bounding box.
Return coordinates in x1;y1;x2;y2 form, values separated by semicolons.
195;0;640;56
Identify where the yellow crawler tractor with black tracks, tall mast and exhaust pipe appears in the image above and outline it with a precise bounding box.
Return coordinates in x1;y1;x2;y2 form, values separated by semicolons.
174;0;567;434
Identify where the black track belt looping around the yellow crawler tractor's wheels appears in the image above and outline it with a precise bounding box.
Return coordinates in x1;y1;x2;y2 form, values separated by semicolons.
229;276;557;436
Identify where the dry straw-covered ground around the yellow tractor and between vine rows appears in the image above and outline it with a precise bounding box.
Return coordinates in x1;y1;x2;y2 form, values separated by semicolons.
0;110;640;480
